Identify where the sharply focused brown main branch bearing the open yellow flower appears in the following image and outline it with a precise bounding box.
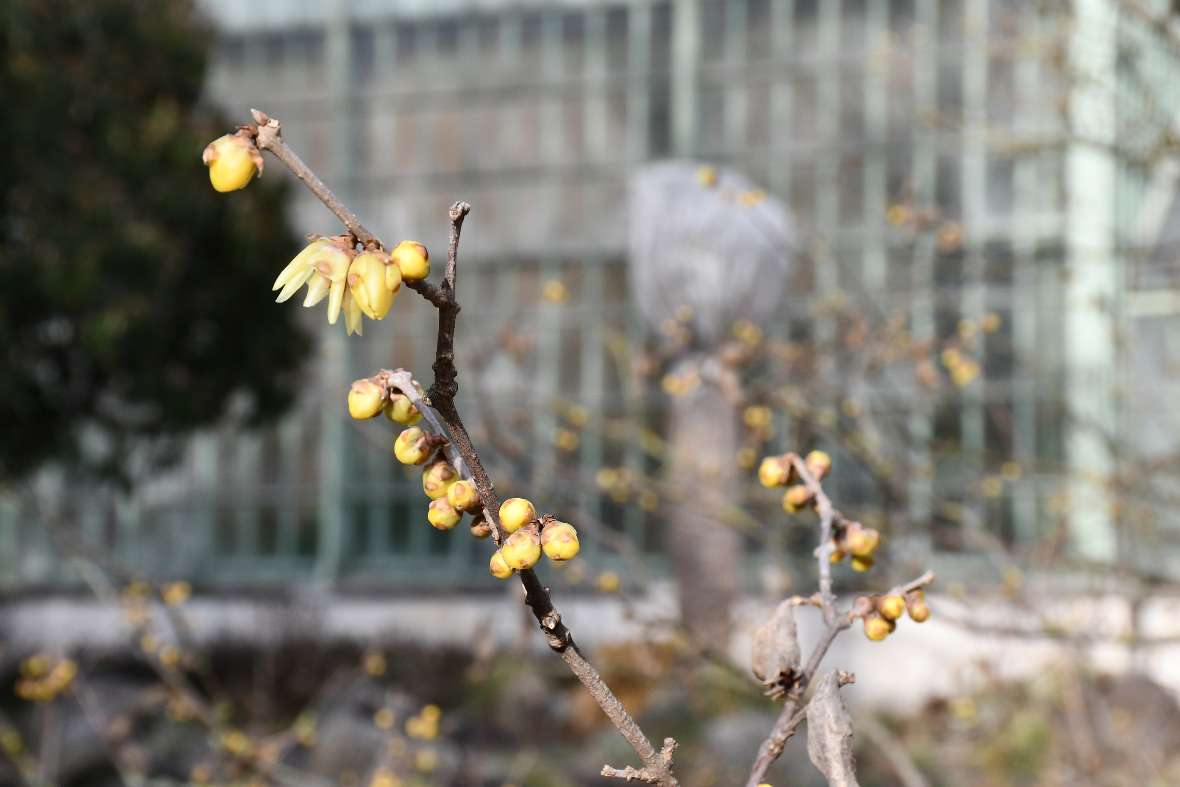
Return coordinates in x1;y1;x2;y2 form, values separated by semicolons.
244;110;677;785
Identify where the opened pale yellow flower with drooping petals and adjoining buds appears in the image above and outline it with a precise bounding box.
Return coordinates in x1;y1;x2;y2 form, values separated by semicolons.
271;235;431;335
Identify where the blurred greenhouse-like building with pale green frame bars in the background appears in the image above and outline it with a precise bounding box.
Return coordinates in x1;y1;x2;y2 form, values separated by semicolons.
0;0;1180;586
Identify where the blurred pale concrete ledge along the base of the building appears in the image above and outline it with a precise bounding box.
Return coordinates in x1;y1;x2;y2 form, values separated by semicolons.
0;586;1180;711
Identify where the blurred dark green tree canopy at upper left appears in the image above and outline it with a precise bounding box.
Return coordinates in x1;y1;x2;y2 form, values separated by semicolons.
0;0;307;479
